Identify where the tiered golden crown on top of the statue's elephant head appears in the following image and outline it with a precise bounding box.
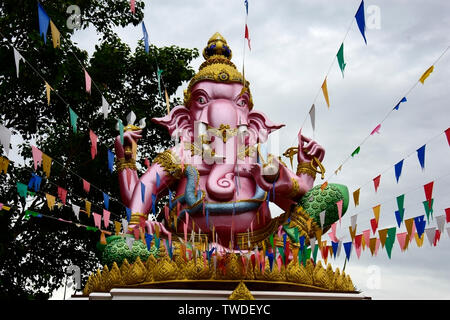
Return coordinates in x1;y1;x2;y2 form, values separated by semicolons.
184;32;253;109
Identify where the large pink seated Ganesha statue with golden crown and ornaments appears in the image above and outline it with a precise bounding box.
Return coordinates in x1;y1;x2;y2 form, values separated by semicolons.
115;33;348;252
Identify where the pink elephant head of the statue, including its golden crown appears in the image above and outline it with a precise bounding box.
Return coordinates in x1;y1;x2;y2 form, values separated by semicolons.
152;33;284;201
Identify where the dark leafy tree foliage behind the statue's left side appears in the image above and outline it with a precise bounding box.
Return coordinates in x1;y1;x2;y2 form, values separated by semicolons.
0;0;198;299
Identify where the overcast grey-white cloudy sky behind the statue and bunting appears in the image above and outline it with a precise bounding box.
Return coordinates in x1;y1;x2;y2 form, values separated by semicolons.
53;0;450;299
